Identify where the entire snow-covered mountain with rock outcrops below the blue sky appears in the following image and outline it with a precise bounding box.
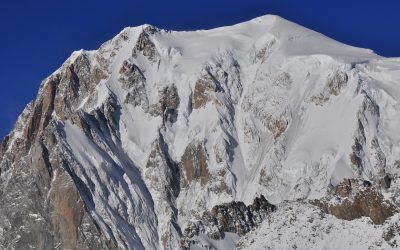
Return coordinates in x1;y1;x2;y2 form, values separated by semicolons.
0;15;400;249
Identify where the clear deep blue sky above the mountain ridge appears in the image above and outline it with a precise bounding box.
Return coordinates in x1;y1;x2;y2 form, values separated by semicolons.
0;0;400;140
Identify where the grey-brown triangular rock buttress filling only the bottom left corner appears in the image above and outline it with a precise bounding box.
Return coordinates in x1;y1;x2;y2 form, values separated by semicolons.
0;126;115;249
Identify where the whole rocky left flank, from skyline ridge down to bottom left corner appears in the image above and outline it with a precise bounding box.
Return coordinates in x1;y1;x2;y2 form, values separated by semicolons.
0;48;112;249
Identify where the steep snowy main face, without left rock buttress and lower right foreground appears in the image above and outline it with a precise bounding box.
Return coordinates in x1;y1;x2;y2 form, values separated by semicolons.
0;16;400;249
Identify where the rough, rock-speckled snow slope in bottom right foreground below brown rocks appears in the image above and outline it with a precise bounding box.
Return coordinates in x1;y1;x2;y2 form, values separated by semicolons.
237;203;399;250
